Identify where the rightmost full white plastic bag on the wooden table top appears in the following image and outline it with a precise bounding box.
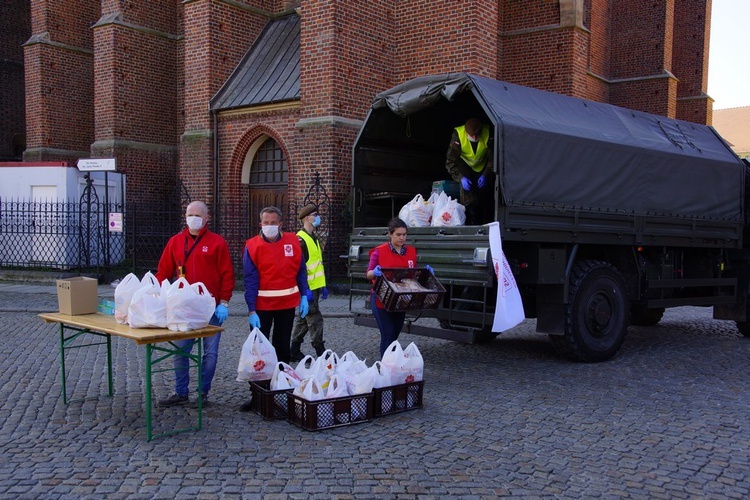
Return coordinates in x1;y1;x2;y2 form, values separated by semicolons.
167;278;216;332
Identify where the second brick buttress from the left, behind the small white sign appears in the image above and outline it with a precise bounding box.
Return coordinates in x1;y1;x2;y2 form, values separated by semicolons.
90;0;183;203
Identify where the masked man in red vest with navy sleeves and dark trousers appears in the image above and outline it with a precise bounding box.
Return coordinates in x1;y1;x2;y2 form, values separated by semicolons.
240;207;309;411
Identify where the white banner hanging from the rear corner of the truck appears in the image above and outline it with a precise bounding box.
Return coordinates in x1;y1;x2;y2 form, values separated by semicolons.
487;222;525;332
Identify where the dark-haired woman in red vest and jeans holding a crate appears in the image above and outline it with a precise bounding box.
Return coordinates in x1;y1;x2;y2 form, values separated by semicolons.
365;217;432;357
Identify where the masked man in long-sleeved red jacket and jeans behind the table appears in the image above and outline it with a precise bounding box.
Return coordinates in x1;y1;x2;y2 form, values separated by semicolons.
156;201;234;406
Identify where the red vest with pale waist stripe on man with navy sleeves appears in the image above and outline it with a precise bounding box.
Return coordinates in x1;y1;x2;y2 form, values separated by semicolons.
245;233;302;311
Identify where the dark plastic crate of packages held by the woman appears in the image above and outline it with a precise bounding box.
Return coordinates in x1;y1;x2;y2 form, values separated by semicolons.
375;267;445;312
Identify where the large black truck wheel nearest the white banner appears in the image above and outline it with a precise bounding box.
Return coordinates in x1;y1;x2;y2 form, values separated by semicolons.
550;260;630;363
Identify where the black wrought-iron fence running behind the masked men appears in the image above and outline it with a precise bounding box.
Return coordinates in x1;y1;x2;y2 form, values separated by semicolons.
0;183;351;280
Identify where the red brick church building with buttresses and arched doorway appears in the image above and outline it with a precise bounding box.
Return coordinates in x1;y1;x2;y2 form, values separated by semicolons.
0;0;724;274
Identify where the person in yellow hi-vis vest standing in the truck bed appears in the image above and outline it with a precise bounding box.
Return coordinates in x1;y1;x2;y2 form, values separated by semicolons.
445;118;495;226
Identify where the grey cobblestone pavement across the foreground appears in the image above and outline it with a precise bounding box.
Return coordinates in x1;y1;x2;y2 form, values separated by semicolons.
0;284;750;499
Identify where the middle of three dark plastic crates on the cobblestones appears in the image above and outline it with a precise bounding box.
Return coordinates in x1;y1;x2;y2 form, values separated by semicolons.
287;392;374;431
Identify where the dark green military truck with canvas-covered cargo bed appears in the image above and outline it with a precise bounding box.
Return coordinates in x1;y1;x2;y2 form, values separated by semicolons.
347;73;750;362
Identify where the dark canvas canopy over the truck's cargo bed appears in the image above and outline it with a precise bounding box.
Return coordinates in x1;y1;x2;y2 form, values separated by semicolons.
360;73;744;221
